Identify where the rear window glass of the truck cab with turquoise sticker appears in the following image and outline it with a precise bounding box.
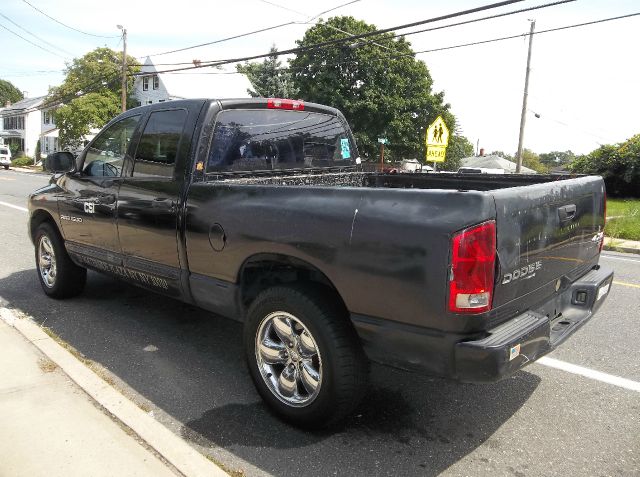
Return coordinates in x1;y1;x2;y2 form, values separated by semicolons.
207;109;356;172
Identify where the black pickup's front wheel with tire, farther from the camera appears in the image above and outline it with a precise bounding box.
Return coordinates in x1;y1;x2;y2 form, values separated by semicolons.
34;222;87;298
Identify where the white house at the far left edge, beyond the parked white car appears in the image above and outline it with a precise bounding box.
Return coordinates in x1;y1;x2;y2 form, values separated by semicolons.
0;96;44;156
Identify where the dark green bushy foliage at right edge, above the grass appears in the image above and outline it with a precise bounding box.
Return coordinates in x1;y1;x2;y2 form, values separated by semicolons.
569;134;640;197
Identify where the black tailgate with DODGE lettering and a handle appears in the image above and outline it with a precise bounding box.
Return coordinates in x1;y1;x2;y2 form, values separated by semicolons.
493;176;605;309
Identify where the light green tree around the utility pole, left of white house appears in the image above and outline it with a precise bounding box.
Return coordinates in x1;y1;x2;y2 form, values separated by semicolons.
45;48;140;149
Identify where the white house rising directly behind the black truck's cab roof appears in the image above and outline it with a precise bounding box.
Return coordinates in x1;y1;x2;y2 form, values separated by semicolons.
133;58;252;106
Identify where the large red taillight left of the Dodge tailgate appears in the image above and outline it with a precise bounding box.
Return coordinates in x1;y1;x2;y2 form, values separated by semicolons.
449;220;496;313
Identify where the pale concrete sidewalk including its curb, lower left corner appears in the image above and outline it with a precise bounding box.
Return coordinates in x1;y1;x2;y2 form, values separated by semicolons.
0;309;226;477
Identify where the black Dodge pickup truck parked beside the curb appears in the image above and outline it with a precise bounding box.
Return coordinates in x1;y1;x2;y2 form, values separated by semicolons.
29;99;613;426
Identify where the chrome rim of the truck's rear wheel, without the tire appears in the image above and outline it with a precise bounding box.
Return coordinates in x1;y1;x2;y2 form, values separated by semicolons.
255;311;322;407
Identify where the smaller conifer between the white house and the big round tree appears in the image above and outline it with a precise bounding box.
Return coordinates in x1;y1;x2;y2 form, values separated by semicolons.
236;45;298;99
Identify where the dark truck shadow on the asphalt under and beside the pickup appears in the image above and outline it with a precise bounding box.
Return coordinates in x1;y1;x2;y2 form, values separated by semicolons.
0;270;540;476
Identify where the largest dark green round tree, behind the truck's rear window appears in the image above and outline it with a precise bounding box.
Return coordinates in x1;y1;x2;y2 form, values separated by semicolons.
290;16;455;159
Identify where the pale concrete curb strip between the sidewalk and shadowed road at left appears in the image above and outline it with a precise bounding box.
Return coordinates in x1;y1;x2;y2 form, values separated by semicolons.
0;308;228;477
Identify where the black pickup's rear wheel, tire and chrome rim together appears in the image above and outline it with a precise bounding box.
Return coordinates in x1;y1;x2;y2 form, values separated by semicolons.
244;285;368;428
